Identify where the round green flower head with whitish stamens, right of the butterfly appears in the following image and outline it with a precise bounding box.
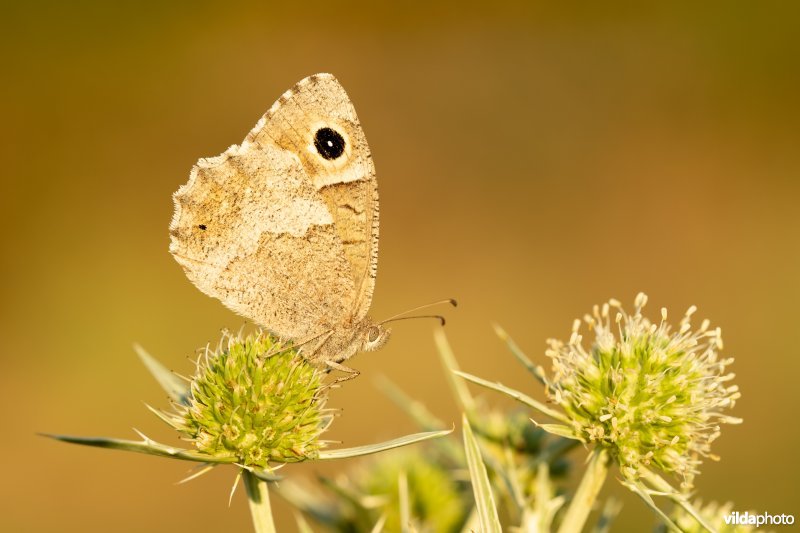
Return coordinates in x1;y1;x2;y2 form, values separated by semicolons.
546;293;741;488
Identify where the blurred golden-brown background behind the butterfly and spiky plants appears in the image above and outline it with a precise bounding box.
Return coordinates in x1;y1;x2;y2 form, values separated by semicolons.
0;1;800;532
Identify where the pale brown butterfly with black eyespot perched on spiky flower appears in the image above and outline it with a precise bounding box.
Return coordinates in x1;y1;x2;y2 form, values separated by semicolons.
170;74;455;377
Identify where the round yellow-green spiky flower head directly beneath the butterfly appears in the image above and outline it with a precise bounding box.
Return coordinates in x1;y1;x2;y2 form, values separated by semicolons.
172;331;326;468
